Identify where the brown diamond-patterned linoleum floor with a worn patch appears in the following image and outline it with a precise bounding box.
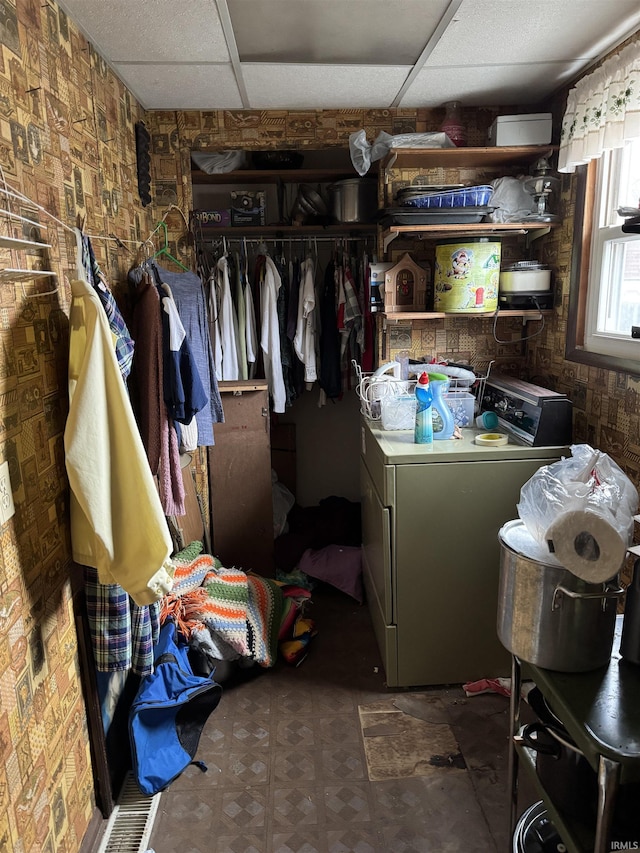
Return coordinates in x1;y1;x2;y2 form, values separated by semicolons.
149;586;528;853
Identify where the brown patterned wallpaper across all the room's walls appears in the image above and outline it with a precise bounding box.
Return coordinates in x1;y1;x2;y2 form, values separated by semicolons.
0;0;640;853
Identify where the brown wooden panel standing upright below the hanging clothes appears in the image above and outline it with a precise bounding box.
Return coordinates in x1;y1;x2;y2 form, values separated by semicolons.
208;379;275;577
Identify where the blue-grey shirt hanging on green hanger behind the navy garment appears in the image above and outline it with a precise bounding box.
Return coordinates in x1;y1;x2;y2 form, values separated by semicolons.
151;261;224;446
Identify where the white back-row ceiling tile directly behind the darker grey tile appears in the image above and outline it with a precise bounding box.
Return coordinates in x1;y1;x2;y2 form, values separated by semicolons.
242;63;411;110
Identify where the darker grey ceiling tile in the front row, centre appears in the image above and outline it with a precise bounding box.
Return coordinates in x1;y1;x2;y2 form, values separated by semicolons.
227;0;449;66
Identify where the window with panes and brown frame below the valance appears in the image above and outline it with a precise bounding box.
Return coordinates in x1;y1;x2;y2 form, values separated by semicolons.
567;140;640;373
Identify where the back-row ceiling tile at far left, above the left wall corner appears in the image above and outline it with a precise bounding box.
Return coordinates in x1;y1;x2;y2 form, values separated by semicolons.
114;62;242;110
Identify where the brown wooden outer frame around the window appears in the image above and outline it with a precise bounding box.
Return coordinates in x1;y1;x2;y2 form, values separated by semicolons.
565;160;640;375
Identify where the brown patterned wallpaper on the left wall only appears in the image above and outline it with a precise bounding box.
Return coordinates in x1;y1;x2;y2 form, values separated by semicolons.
0;0;153;853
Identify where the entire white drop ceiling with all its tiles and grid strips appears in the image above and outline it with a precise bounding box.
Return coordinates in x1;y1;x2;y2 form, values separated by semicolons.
56;0;640;109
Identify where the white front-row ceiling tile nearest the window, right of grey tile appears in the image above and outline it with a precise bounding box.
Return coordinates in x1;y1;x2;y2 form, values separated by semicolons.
426;0;640;66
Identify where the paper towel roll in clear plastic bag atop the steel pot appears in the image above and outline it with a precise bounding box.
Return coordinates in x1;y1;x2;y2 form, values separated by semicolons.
545;510;627;583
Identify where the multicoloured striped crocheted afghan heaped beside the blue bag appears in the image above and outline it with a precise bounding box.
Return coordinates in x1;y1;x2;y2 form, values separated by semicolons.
160;542;283;667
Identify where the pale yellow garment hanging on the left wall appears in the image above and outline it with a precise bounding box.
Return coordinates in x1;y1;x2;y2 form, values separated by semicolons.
64;280;173;605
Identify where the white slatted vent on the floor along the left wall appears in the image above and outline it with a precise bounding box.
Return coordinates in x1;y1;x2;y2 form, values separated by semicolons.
97;773;162;853
